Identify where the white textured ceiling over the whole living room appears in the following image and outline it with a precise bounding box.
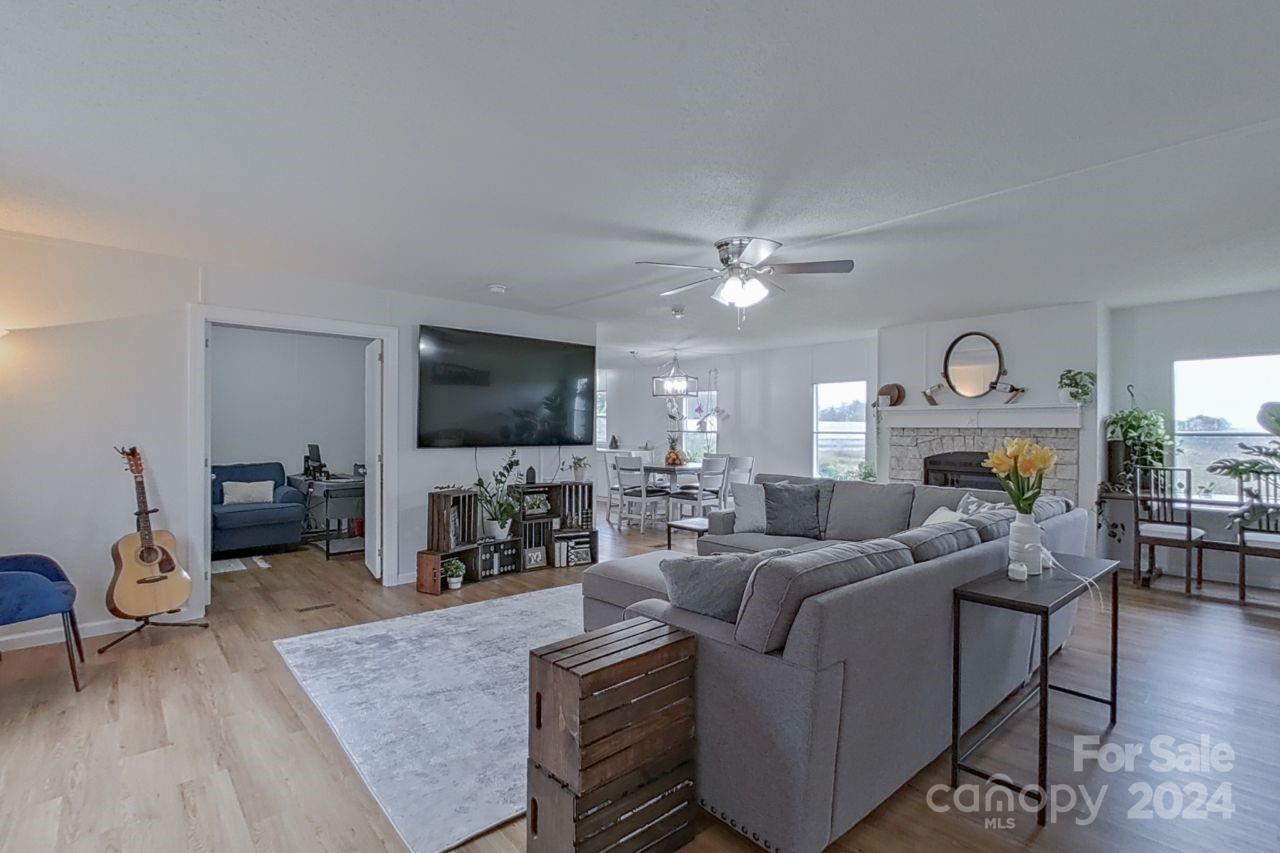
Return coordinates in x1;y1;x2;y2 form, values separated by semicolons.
0;0;1280;352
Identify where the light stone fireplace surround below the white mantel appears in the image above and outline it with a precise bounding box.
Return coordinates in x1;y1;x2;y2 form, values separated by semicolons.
888;427;1080;503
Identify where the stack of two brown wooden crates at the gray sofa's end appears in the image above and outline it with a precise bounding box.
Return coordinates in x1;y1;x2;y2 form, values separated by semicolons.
526;619;695;853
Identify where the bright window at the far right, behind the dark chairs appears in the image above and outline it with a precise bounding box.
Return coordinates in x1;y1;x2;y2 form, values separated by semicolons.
1174;355;1280;498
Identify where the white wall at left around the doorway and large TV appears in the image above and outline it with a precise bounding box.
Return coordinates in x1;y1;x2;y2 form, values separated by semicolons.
0;232;595;648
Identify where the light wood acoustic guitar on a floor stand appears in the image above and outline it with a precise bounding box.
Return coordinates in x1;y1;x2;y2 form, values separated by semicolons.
106;447;191;620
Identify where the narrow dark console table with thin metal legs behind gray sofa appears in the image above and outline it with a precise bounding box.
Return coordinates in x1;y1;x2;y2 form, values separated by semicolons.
951;553;1120;826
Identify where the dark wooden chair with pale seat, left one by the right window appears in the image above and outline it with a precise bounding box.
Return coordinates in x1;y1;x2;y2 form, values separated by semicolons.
1133;465;1204;596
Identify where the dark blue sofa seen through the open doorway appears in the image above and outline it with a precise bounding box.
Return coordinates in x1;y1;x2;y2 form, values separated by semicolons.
212;462;306;553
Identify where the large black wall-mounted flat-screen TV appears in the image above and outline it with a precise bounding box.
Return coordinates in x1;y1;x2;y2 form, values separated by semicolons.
417;325;595;447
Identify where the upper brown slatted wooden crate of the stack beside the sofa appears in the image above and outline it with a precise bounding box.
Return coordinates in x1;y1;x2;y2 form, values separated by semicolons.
529;619;695;795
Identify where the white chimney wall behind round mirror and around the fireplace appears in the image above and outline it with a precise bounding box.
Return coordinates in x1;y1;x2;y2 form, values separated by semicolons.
878;302;1106;517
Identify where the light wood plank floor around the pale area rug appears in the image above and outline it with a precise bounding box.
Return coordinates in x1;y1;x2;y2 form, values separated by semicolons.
0;517;1280;853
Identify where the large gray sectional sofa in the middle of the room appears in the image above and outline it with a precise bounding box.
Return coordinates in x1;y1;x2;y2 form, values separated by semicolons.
582;475;1088;852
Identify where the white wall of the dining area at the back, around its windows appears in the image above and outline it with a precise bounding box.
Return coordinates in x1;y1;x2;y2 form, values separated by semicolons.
593;337;878;474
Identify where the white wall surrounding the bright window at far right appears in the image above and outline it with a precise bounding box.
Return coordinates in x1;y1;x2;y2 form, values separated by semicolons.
1108;291;1280;588
